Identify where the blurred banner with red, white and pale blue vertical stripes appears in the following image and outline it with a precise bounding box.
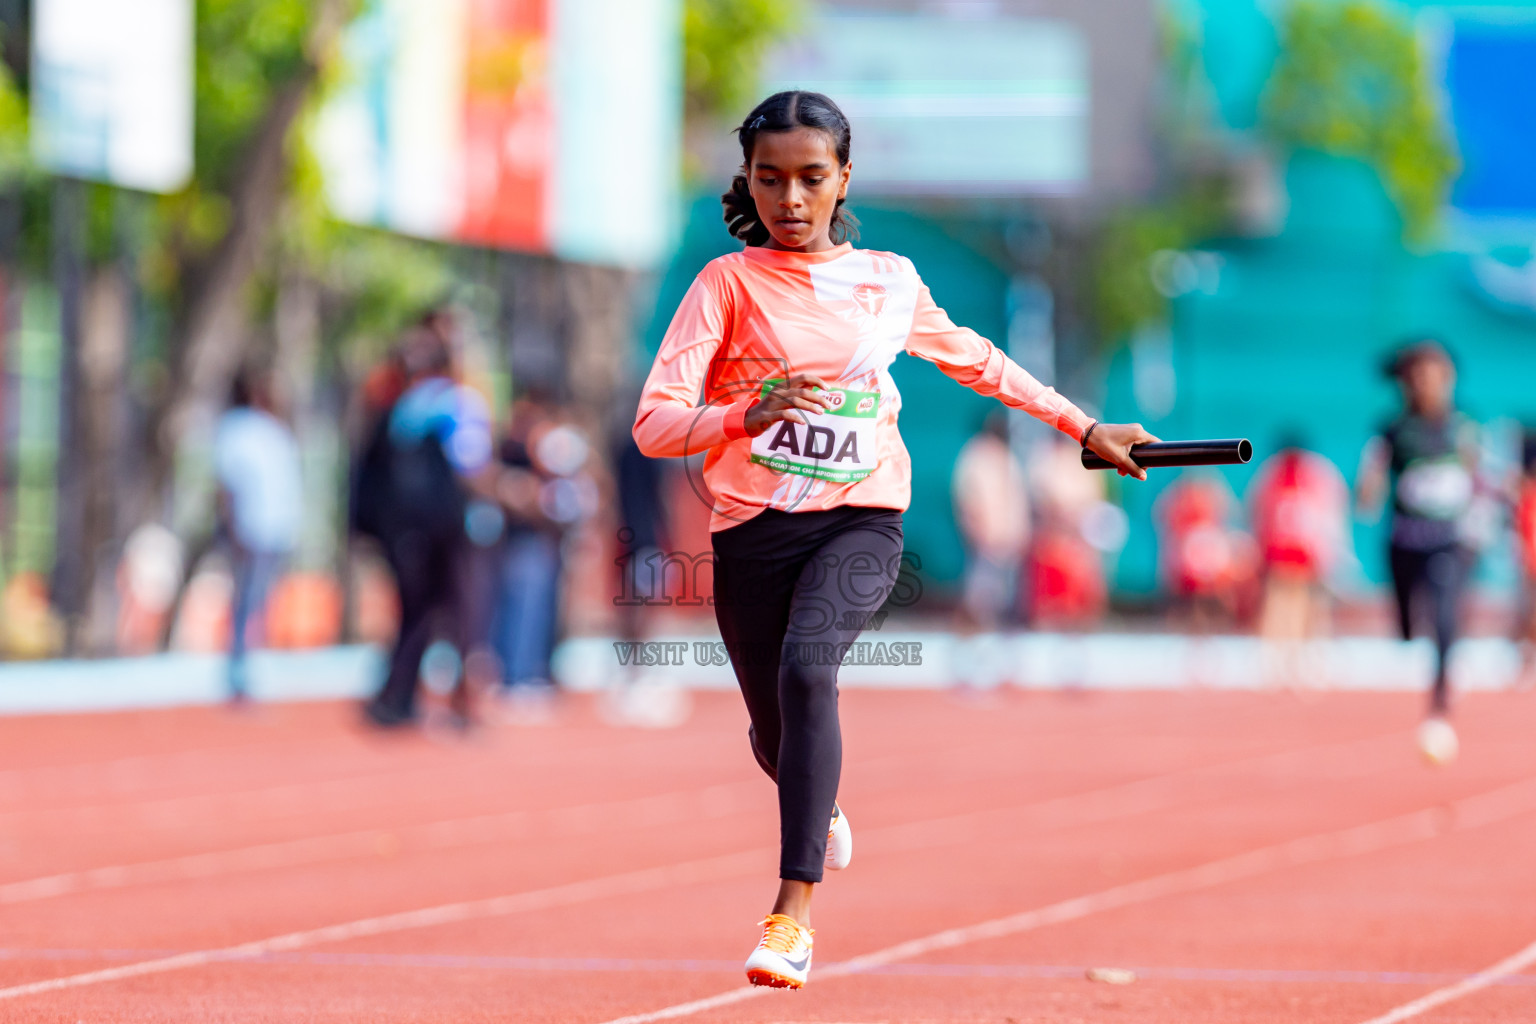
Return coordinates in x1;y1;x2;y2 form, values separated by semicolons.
315;0;682;266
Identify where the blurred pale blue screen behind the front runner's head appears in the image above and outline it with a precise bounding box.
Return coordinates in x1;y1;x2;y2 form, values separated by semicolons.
763;12;1089;197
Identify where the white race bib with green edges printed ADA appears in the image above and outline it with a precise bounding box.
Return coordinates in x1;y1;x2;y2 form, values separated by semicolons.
753;379;880;484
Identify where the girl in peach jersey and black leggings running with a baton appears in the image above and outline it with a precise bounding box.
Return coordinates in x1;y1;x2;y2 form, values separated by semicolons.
634;92;1154;989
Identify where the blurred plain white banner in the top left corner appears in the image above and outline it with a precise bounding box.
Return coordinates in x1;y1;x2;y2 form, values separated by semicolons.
32;0;192;192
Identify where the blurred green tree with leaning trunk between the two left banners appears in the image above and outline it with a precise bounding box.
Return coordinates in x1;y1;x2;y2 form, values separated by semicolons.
0;0;450;516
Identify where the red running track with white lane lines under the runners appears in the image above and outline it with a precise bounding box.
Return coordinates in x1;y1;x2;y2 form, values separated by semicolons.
0;691;1536;1024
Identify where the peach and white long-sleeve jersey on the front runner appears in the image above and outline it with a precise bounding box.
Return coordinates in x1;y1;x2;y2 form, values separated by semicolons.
634;243;1092;530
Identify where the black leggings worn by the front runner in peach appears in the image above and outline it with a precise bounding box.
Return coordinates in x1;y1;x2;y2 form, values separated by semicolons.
714;505;902;881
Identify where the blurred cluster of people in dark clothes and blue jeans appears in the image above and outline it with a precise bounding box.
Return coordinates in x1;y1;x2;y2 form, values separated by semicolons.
349;310;602;726
